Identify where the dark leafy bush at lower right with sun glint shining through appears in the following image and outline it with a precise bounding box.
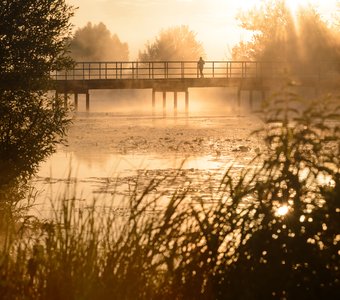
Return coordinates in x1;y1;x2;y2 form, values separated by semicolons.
229;85;340;299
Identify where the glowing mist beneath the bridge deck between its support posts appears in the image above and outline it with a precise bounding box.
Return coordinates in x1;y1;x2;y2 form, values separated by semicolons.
73;87;240;117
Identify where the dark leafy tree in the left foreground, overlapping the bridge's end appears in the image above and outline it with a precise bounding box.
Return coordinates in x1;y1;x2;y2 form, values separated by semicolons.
0;0;73;190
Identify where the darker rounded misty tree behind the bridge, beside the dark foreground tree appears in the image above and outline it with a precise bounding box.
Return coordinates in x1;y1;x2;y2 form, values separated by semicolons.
70;22;129;61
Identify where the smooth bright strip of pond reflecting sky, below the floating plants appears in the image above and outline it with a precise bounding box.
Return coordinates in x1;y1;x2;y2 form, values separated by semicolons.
38;152;226;179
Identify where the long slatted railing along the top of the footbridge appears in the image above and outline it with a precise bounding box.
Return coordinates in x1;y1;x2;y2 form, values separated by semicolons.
51;61;340;80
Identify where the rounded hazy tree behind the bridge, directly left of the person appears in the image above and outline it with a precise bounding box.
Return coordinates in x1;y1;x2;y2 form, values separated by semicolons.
139;25;205;61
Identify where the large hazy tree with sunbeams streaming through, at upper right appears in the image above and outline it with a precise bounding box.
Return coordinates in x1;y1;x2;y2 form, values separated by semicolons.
232;0;340;69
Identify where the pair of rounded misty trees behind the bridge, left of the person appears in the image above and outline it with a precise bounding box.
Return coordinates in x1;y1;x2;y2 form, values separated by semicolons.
70;23;205;61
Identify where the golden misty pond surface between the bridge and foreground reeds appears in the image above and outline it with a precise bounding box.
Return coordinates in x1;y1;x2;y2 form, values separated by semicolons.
34;89;259;214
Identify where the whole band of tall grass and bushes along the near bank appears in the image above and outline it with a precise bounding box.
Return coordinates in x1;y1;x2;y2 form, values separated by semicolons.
0;90;340;299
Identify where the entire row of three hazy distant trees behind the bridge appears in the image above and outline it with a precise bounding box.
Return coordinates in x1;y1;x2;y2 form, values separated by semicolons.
70;0;340;68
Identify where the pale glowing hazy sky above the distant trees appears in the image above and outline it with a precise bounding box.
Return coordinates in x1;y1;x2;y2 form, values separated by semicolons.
67;0;337;60
